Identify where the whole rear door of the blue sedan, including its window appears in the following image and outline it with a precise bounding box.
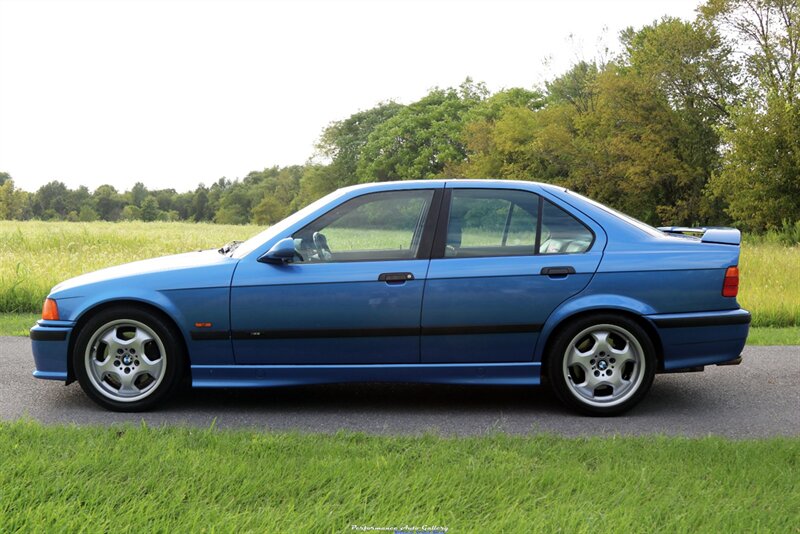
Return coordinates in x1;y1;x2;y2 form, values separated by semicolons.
421;182;604;363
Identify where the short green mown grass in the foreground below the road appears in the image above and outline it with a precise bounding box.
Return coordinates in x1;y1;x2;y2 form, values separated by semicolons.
0;421;800;533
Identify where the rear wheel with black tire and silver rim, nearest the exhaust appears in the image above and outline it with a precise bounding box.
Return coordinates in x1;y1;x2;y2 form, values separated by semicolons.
547;314;656;416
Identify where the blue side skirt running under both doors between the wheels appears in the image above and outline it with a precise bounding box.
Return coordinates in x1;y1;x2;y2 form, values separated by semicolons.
192;362;541;388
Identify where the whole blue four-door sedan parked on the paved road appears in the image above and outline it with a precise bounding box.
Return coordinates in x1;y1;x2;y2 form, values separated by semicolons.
31;180;750;415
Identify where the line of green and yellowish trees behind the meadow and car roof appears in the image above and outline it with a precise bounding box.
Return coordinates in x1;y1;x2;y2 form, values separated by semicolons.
0;0;800;231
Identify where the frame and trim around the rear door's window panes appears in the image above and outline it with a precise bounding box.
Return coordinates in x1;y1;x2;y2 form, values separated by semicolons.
430;187;597;260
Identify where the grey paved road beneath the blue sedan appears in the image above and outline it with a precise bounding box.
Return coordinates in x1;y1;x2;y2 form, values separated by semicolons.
0;337;800;438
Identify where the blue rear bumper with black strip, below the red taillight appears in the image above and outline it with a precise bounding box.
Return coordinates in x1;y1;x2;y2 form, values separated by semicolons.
646;309;750;371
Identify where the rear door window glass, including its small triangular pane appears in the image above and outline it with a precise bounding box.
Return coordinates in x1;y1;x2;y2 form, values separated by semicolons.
440;189;594;258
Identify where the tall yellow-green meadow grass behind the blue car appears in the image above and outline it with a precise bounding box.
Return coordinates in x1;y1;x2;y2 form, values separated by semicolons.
0;221;800;327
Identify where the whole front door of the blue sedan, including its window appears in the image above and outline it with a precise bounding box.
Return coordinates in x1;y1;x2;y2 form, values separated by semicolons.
231;189;442;365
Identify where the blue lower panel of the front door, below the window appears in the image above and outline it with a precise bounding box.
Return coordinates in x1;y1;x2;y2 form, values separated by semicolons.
231;260;429;364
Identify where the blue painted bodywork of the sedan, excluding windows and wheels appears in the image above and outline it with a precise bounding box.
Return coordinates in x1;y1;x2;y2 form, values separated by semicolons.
32;180;748;394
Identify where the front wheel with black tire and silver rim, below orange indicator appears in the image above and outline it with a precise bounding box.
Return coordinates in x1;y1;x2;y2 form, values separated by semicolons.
72;306;186;412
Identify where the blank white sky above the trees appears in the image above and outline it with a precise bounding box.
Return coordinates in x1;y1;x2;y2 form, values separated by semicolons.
0;0;699;191
